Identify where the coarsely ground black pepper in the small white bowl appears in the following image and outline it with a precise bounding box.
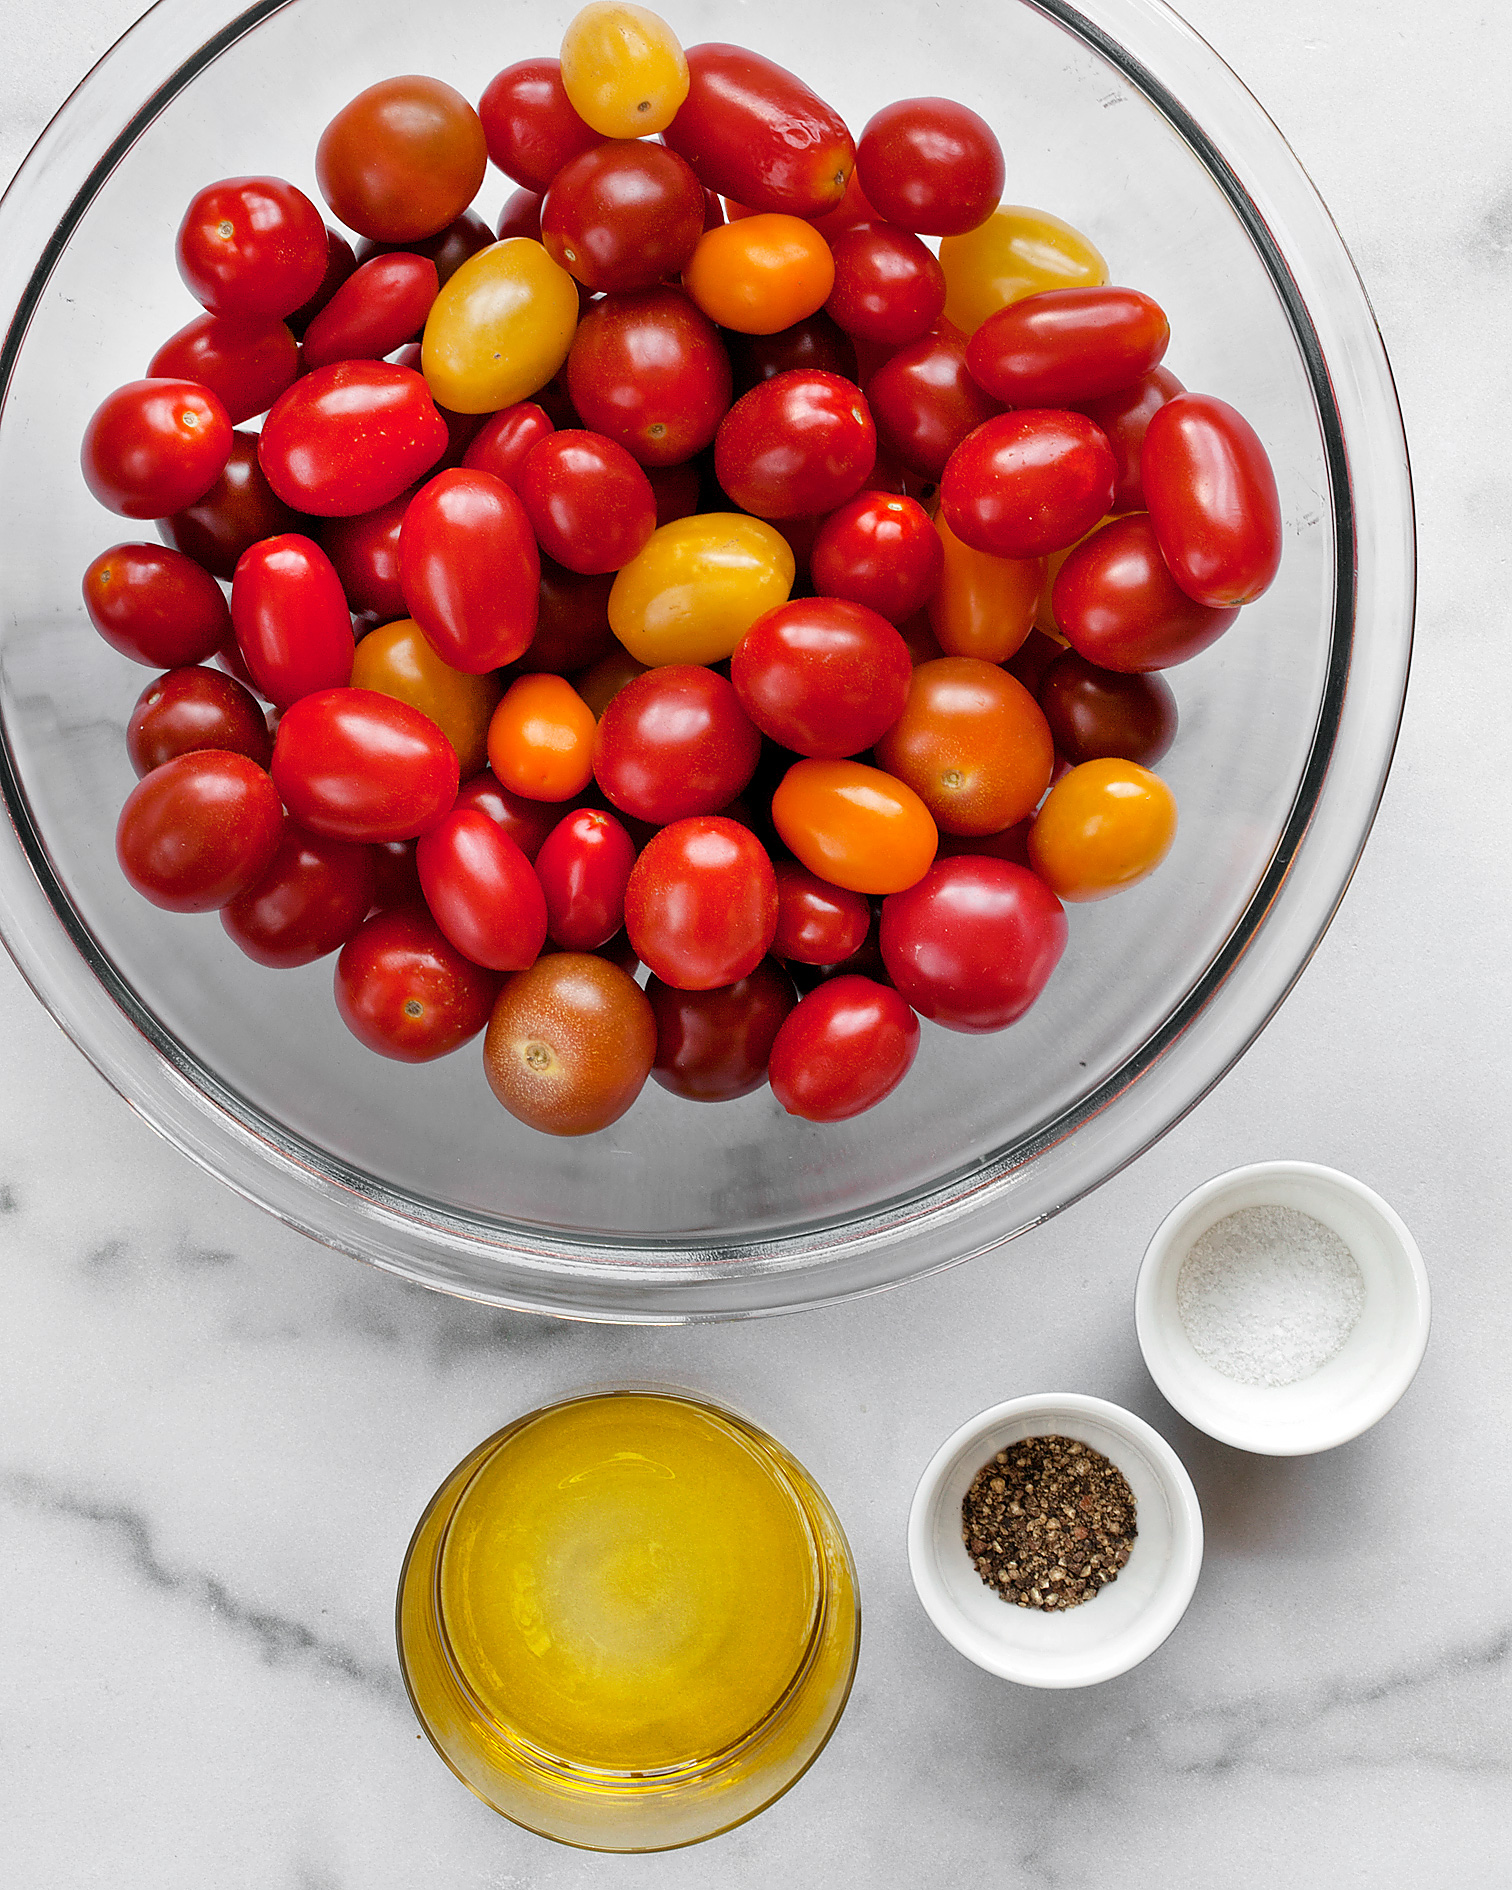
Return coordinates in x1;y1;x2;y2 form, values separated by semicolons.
960;1436;1138;1612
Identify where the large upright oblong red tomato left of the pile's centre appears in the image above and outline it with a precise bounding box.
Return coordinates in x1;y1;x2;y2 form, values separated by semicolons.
399;467;541;677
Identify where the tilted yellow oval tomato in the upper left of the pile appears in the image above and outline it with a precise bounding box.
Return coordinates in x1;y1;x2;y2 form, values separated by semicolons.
420;236;578;414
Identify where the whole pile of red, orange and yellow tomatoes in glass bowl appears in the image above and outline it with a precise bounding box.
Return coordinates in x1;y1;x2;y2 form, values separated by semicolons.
73;0;1281;1134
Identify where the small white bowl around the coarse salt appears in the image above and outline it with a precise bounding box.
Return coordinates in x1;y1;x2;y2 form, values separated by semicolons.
1134;1162;1429;1457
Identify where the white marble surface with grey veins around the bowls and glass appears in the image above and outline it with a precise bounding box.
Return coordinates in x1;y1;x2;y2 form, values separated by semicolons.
0;0;1512;1890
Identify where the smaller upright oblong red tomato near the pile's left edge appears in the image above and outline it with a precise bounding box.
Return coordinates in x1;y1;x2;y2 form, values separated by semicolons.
231;531;355;709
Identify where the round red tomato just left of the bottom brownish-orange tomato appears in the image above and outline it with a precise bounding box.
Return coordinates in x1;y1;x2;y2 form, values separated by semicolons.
336;905;499;1062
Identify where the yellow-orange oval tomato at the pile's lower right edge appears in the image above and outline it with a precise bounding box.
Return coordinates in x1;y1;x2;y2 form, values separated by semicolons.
1028;760;1176;902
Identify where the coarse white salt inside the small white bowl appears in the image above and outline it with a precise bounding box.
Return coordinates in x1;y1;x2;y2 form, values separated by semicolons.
1176;1208;1365;1385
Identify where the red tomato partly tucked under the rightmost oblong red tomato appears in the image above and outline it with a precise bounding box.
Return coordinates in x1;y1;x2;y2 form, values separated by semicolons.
1053;512;1238;671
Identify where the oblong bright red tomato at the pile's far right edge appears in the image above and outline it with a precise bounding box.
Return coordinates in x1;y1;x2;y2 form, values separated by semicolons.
1140;393;1281;610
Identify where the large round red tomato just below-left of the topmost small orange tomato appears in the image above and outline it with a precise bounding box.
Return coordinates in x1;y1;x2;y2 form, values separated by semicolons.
567;287;730;467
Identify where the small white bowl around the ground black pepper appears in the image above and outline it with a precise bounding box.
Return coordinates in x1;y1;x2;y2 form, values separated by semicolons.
909;1391;1202;1686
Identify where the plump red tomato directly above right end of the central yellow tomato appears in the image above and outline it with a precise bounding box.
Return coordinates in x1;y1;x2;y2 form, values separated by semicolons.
714;369;877;518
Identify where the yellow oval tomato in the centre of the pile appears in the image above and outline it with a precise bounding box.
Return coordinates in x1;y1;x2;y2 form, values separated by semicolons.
609;512;796;669
